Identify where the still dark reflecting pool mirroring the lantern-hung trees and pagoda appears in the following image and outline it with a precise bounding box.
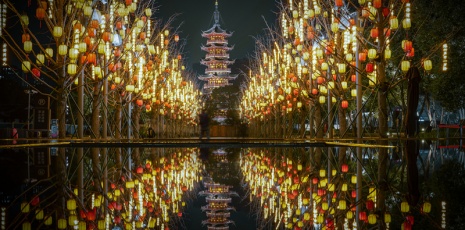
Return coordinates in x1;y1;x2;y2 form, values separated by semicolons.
0;140;465;229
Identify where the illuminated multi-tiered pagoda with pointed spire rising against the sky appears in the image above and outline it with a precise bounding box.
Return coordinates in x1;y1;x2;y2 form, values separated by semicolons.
199;1;237;94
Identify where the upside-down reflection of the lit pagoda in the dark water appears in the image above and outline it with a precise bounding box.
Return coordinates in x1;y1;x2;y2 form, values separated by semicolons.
199;179;238;227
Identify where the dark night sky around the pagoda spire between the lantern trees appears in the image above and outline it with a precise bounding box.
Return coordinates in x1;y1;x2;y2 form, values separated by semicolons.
155;0;278;66
